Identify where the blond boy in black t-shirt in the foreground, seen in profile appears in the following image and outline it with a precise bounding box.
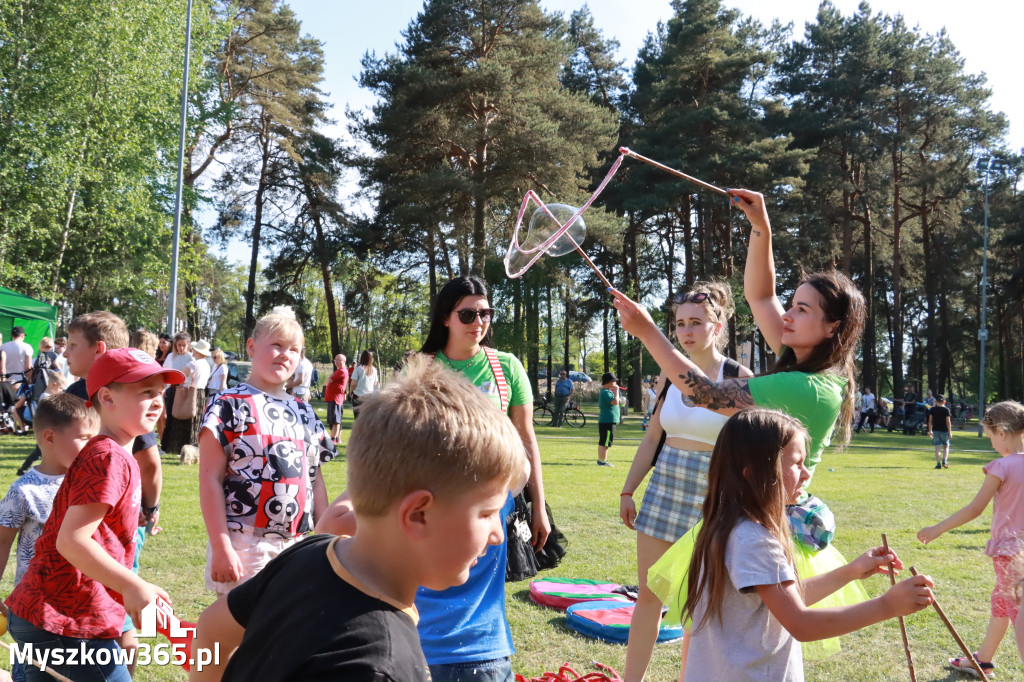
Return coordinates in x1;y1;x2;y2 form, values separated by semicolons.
189;359;527;682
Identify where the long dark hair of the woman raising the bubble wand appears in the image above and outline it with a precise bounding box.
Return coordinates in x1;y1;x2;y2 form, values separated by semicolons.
775;270;866;445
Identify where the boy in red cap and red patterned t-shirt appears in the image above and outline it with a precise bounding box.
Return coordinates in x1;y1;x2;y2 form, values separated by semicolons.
6;348;184;682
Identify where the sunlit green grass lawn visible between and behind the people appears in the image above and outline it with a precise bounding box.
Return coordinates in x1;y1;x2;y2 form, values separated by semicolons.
0;410;1024;681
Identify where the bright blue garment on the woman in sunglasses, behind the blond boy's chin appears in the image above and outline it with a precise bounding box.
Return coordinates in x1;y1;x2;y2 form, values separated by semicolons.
416;495;515;666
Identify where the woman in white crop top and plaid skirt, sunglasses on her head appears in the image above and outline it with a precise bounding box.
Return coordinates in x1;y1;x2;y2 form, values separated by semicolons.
618;282;753;680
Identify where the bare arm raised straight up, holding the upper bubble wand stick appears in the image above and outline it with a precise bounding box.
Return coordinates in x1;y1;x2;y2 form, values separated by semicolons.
729;189;785;355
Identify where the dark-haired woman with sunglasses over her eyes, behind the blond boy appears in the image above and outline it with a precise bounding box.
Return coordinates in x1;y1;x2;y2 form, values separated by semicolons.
416;276;551;682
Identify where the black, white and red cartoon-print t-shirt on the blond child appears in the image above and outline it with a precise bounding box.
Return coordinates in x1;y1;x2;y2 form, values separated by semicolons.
203;384;336;538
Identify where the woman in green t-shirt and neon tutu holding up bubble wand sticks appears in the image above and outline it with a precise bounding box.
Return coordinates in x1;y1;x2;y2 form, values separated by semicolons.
611;189;866;682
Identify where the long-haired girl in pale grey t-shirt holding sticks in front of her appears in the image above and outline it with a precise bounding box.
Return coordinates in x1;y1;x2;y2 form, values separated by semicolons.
681;409;933;682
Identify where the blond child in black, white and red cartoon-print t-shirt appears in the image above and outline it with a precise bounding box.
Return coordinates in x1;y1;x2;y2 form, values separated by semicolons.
199;308;335;594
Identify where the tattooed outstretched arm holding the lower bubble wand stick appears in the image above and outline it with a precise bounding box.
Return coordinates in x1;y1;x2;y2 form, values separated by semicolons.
611;290;754;416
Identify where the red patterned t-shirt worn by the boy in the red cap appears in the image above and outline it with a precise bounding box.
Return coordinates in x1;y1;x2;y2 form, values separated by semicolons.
6;435;142;639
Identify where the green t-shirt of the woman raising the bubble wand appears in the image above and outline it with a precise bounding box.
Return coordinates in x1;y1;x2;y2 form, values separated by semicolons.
748;372;846;475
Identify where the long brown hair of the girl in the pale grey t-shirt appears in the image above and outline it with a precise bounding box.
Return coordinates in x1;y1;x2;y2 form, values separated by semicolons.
683;409;807;629
